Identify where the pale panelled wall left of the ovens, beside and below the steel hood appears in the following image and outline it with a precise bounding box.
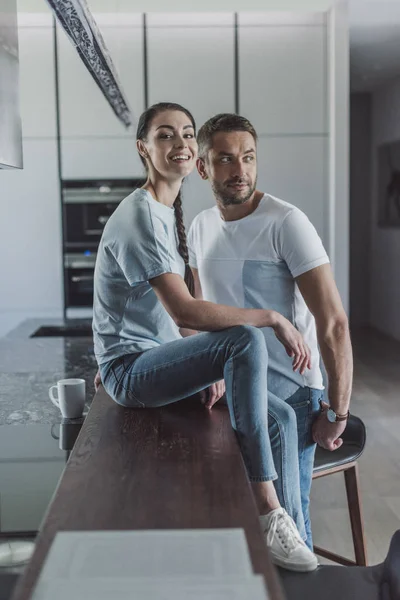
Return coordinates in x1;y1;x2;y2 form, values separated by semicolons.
0;5;63;336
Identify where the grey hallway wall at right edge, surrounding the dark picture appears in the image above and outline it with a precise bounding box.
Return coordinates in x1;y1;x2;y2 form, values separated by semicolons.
370;80;400;340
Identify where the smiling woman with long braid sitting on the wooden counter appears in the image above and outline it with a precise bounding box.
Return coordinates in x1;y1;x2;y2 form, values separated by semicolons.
93;103;318;571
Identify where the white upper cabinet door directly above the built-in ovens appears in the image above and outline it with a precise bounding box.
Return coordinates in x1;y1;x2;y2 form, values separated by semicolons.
58;19;144;179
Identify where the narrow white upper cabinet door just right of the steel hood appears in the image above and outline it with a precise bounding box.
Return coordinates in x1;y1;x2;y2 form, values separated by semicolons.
18;26;56;138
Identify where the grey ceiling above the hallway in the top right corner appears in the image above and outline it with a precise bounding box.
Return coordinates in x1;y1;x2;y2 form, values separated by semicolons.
349;0;400;92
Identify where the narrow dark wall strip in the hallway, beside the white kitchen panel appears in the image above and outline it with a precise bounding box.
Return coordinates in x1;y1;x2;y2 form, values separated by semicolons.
350;93;372;327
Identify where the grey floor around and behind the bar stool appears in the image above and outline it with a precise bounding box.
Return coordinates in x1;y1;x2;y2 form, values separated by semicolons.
311;329;400;564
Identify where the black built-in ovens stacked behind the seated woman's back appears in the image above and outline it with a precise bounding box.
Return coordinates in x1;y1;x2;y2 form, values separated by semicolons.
62;179;144;310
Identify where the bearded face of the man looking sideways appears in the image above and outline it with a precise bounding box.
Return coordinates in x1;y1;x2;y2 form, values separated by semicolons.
197;131;257;206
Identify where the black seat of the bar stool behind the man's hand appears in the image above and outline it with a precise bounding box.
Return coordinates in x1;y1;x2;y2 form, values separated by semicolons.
314;415;366;474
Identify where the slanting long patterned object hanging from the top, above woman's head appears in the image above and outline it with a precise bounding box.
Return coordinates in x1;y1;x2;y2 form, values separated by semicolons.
45;0;132;127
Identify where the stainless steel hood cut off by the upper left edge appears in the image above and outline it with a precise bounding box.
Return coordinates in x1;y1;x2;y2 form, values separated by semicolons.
0;0;22;169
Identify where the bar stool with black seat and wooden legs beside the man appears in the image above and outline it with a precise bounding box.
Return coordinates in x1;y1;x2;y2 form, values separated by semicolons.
313;415;367;566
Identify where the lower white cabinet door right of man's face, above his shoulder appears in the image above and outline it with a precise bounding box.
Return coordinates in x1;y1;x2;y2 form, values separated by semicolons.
257;137;328;247
